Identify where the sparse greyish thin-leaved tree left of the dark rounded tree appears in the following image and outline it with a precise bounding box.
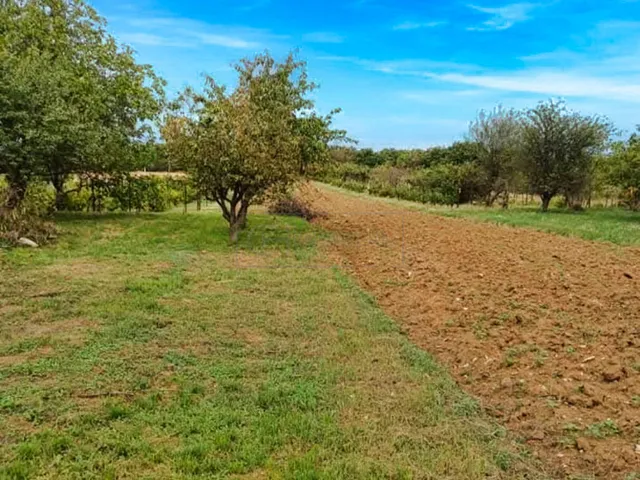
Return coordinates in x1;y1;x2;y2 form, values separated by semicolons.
468;106;521;207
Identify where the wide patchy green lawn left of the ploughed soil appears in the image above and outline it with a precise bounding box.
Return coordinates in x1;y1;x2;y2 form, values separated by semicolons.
0;208;542;479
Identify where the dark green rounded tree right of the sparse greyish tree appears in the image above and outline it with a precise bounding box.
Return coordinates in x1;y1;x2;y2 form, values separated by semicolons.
522;101;611;212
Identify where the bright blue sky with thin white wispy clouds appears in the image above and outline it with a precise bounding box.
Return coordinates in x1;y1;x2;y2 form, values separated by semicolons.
92;0;640;149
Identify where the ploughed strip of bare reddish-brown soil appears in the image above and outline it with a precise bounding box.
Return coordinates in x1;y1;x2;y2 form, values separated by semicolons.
304;189;640;479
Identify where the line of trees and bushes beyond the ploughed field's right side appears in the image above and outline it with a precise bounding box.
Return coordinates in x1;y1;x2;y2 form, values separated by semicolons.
317;101;640;211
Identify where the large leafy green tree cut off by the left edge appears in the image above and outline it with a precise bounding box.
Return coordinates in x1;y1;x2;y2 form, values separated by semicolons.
0;0;163;214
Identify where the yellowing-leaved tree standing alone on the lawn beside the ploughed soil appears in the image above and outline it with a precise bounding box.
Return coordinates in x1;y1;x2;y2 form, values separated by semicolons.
168;53;340;242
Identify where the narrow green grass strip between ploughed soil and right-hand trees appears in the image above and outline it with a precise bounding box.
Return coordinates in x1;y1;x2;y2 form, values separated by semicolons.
322;184;640;246
